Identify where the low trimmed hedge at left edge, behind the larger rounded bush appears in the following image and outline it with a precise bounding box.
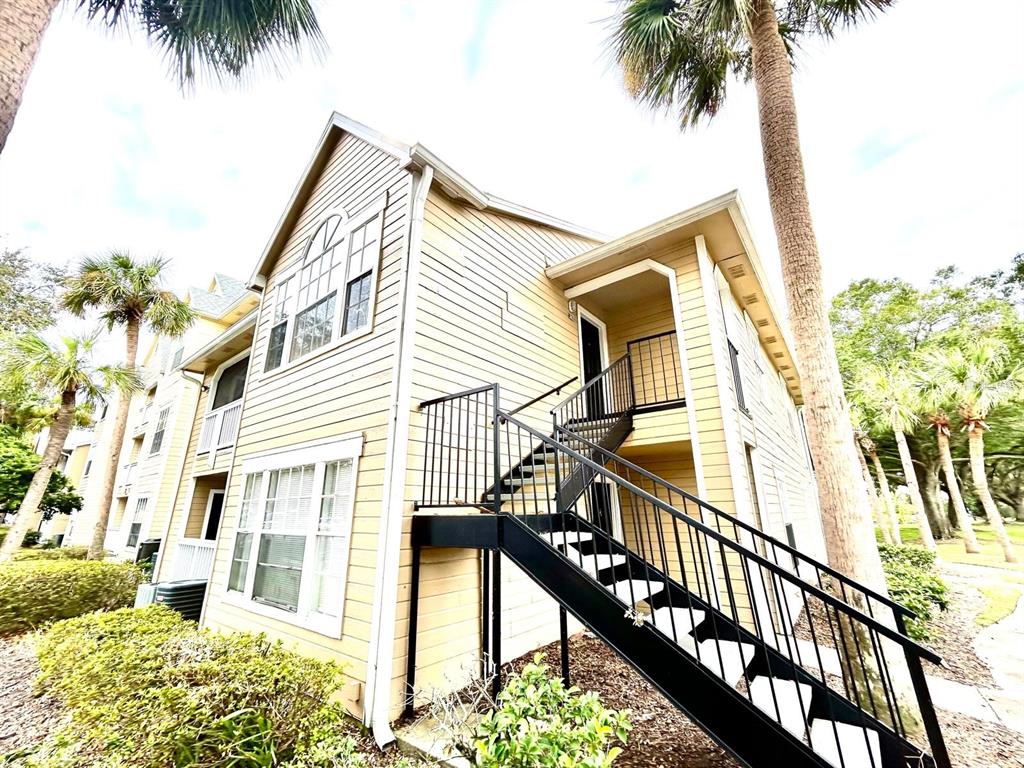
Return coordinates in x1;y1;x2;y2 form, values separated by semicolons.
0;560;142;637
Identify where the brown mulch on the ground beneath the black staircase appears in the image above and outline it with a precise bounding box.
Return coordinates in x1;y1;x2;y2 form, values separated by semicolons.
506;633;738;768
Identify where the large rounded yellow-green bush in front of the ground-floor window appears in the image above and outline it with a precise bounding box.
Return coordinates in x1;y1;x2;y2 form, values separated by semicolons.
22;605;374;768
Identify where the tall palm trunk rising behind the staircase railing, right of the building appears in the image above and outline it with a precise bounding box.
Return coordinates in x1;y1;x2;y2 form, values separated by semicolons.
751;0;886;591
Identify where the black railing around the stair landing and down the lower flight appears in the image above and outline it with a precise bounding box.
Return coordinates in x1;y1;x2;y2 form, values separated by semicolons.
418;385;949;768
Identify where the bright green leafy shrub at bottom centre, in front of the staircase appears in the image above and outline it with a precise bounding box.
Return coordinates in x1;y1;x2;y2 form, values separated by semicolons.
476;653;632;768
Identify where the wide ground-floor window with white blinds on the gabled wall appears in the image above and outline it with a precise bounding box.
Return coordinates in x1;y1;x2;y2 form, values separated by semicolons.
227;436;362;637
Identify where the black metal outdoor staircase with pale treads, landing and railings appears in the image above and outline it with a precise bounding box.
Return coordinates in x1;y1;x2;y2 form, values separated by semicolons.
409;366;949;768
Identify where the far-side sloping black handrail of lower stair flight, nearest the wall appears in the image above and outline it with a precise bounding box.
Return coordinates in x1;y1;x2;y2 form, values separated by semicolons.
555;427;918;618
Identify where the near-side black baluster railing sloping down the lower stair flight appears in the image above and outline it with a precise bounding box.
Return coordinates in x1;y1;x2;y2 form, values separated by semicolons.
496;409;949;768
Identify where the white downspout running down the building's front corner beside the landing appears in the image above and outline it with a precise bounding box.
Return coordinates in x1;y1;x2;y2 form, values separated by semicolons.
362;166;433;746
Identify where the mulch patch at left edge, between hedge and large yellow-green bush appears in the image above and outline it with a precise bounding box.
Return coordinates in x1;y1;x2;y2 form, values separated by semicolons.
0;637;63;755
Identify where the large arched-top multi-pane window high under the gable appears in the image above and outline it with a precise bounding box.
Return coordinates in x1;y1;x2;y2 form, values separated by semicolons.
264;199;385;371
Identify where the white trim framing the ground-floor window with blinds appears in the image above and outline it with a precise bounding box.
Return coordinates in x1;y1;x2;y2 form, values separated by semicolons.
221;433;364;639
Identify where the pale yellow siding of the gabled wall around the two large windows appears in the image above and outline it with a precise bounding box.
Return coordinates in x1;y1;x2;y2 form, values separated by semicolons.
204;134;411;713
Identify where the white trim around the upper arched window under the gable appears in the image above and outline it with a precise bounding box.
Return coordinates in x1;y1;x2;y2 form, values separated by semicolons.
260;194;387;381
